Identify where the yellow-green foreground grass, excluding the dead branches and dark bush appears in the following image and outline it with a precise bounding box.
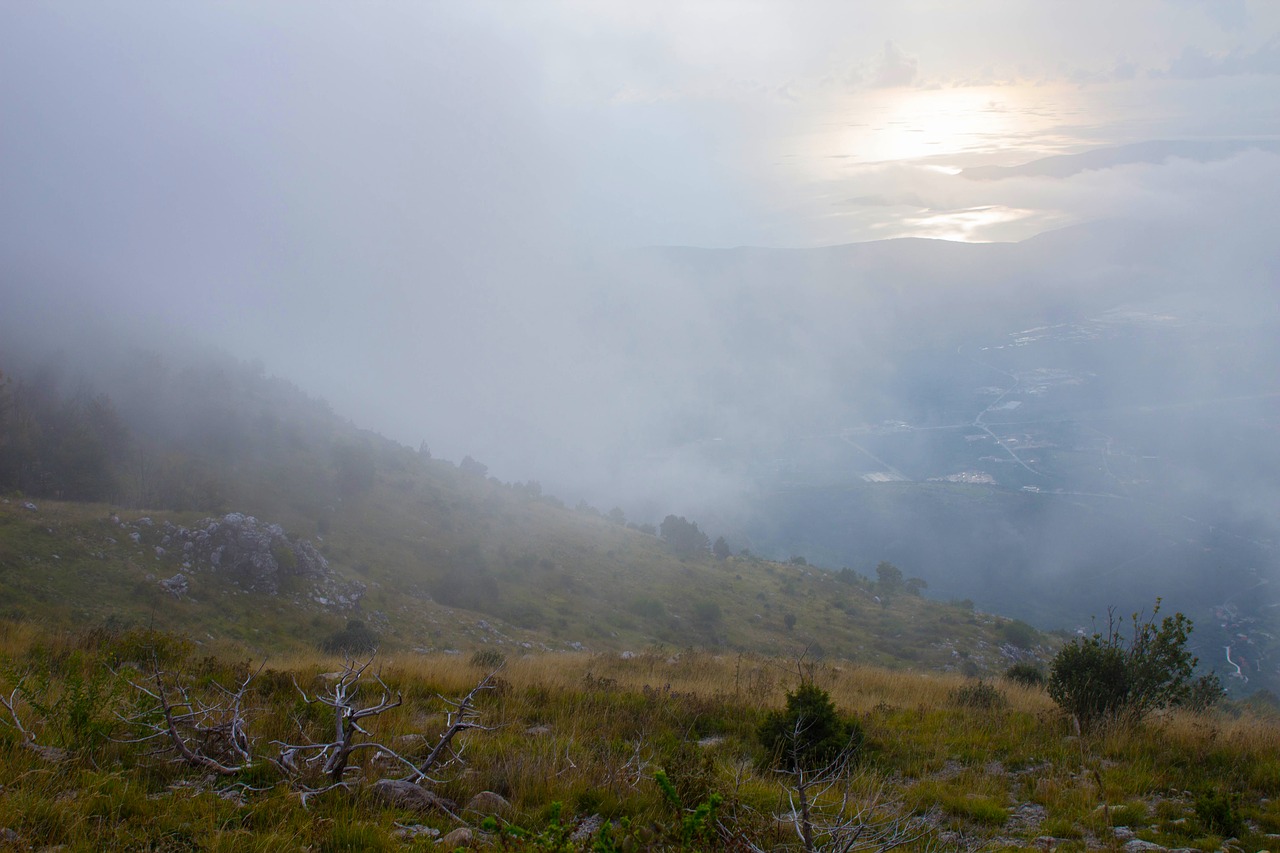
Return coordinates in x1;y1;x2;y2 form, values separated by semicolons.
0;621;1280;850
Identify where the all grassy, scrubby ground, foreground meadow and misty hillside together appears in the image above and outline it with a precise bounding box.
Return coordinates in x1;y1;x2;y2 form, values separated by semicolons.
0;348;1259;852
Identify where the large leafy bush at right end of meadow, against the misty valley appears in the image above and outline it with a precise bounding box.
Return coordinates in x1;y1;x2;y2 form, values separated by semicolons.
1048;598;1217;727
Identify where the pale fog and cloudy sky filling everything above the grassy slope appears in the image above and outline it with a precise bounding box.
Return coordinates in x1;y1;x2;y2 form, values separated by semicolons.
0;0;1280;630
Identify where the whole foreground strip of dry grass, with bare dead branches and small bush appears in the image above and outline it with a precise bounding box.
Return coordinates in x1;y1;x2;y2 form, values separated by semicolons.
0;621;1280;850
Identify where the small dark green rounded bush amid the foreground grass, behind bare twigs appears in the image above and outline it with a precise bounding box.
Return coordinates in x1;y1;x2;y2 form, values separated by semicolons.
756;681;865;771
